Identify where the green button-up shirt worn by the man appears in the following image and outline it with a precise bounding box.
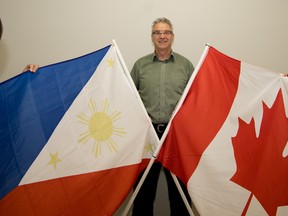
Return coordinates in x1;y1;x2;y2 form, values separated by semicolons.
131;52;194;124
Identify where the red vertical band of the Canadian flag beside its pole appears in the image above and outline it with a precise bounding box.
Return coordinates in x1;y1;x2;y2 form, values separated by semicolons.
158;47;241;184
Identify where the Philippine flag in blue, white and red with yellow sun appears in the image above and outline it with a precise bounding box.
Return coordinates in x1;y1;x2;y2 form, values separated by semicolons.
0;45;158;215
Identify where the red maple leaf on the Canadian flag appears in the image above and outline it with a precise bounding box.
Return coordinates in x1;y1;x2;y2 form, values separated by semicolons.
231;90;288;215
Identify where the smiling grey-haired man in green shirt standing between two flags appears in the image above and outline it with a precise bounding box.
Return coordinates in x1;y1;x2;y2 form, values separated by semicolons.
131;18;194;216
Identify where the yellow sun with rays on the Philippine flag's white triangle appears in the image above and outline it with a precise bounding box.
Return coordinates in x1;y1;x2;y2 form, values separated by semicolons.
77;99;126;157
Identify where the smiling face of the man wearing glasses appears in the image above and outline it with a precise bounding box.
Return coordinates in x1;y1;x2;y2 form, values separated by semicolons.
151;22;174;51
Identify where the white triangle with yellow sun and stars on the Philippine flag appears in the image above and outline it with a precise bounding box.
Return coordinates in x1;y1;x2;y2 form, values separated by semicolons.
20;46;158;185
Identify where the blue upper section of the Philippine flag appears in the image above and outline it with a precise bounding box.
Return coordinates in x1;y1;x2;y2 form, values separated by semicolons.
0;45;110;199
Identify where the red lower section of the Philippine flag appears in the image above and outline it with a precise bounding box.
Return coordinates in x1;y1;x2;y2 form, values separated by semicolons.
0;164;144;216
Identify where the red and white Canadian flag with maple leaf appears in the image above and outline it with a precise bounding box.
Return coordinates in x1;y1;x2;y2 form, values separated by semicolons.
158;46;288;216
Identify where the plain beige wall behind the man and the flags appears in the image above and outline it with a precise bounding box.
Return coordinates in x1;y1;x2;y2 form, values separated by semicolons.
0;0;288;216
